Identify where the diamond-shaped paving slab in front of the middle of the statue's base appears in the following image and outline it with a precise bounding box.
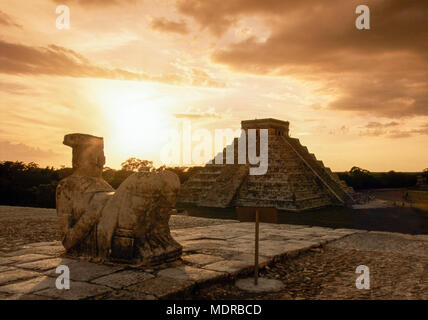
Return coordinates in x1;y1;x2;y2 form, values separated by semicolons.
91;270;154;289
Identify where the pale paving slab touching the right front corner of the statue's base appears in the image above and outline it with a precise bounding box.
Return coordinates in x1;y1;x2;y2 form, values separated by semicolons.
158;266;226;284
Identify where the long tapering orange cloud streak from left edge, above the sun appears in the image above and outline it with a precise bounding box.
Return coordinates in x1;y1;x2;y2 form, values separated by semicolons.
0;40;224;87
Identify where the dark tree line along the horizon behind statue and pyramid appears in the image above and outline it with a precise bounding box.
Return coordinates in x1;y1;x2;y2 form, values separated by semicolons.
0;158;417;208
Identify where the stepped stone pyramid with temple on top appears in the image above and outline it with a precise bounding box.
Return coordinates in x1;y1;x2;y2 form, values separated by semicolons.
177;119;353;211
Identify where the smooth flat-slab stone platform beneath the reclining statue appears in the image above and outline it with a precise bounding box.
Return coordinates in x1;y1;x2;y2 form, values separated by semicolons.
0;223;364;300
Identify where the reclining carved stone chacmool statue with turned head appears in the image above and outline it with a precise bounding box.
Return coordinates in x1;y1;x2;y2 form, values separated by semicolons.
56;134;182;265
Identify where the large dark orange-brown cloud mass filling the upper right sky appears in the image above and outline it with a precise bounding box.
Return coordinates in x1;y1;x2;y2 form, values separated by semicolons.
177;0;428;118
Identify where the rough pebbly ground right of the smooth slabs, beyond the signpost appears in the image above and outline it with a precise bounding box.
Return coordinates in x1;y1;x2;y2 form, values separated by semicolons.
197;232;428;300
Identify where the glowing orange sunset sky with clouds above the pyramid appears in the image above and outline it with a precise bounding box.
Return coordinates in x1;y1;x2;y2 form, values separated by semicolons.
0;0;428;171
